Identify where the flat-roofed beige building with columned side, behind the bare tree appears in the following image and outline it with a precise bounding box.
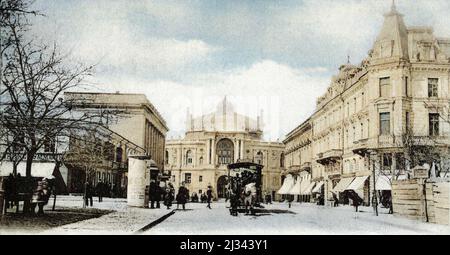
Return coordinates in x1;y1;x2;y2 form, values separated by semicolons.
65;92;168;196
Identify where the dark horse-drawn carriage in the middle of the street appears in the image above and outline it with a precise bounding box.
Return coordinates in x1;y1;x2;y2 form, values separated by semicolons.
228;162;263;216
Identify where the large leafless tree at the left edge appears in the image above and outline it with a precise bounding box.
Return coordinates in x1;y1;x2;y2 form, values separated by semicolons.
0;19;123;212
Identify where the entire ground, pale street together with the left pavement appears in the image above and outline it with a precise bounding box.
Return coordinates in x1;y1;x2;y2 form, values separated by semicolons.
0;196;450;235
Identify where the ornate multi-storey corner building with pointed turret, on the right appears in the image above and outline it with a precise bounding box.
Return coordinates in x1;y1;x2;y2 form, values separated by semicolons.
284;5;450;204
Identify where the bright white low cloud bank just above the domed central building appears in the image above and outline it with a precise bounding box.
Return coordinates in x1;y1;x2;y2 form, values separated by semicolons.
89;60;329;140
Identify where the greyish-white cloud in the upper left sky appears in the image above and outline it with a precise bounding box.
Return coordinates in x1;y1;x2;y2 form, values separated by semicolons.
29;1;219;77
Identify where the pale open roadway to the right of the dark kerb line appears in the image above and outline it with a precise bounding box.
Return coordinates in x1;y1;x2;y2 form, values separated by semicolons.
145;201;450;235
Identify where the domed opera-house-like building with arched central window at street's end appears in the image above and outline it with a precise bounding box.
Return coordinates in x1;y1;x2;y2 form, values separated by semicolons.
165;98;284;198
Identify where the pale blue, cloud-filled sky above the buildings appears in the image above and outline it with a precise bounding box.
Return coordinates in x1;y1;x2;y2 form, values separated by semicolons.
31;0;450;141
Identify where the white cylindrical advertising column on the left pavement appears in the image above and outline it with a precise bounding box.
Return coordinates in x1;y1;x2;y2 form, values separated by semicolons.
127;157;150;207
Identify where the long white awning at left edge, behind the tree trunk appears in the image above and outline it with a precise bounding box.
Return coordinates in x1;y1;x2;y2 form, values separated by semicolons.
0;161;55;179
